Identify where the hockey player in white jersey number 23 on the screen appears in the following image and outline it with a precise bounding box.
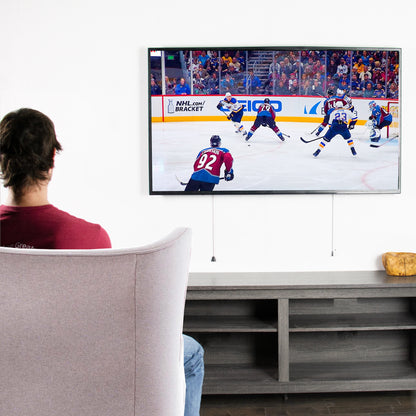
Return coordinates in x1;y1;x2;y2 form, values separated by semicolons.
313;101;357;157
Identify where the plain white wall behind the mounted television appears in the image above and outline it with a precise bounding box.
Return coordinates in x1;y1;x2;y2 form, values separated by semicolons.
0;0;416;271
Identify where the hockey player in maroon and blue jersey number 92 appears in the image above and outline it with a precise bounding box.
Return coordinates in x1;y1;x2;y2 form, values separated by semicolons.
185;135;234;192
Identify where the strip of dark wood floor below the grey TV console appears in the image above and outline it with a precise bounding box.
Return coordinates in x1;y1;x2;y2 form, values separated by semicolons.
201;392;416;416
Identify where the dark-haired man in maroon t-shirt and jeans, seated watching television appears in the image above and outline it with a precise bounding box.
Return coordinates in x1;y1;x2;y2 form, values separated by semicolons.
0;108;204;416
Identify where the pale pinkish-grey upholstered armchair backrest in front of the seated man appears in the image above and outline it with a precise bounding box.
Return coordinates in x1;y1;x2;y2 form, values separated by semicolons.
0;228;191;416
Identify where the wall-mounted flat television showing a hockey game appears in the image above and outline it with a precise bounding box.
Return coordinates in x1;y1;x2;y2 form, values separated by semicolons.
148;46;401;195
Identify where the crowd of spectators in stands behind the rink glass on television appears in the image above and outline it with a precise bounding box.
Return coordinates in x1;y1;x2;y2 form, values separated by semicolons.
151;50;400;99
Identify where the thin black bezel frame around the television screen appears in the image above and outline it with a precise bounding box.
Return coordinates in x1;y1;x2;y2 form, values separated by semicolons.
147;45;403;196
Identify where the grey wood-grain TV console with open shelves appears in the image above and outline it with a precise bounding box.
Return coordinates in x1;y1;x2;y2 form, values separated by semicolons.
184;271;416;394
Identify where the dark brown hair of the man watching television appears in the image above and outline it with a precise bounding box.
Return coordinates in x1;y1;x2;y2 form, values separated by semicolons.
0;108;62;200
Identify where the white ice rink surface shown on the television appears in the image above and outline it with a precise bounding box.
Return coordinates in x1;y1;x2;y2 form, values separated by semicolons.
152;119;400;192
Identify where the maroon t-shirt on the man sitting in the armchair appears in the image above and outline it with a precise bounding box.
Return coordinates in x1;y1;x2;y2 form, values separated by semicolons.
0;205;111;250
